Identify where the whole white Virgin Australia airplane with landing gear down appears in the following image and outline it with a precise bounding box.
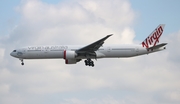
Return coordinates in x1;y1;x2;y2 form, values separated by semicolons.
10;24;167;67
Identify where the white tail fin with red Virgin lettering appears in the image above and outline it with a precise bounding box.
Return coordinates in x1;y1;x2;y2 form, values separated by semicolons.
142;26;163;48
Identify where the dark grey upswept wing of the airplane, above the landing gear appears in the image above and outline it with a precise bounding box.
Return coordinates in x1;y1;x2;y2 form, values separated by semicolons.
76;34;112;53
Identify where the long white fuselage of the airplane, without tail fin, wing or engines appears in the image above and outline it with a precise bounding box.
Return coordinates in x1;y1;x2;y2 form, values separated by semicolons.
11;45;164;59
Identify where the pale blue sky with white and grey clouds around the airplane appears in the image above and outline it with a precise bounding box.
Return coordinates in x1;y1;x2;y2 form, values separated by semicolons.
0;0;180;104
